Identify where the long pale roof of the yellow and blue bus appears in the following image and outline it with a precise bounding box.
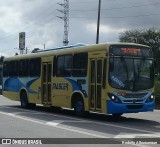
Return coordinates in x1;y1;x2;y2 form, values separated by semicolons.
4;42;149;61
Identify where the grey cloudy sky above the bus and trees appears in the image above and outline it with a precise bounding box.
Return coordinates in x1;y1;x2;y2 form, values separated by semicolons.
0;0;160;56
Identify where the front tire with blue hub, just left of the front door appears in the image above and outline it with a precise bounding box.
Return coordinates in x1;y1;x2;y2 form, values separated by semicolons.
73;98;85;116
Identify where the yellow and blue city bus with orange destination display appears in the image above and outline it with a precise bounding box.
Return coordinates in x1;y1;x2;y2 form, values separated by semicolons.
3;43;155;116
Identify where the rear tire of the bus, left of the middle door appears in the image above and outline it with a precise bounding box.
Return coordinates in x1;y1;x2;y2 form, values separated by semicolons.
20;91;29;109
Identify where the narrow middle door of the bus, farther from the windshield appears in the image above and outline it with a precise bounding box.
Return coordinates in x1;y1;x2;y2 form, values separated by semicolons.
42;58;52;105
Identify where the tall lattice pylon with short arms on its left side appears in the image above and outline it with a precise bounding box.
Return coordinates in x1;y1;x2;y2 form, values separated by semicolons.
57;0;69;46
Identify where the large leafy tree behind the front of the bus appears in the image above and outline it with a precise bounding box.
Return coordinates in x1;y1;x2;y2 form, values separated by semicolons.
119;28;160;60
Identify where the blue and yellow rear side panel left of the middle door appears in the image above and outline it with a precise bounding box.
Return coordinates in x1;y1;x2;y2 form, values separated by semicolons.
3;77;41;103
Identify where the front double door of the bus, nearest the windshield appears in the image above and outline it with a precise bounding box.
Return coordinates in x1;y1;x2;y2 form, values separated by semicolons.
89;58;104;111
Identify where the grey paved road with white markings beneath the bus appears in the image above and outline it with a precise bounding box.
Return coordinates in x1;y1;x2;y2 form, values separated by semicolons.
0;96;160;146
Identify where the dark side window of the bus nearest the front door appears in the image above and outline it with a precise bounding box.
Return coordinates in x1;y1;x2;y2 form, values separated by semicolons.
73;53;88;77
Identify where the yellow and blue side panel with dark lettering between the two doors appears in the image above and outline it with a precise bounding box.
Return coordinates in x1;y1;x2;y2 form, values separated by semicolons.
52;77;88;110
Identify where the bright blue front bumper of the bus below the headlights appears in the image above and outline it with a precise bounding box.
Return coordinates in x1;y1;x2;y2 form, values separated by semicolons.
107;100;155;114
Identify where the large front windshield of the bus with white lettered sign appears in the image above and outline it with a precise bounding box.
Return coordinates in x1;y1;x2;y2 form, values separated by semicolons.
109;57;154;91
